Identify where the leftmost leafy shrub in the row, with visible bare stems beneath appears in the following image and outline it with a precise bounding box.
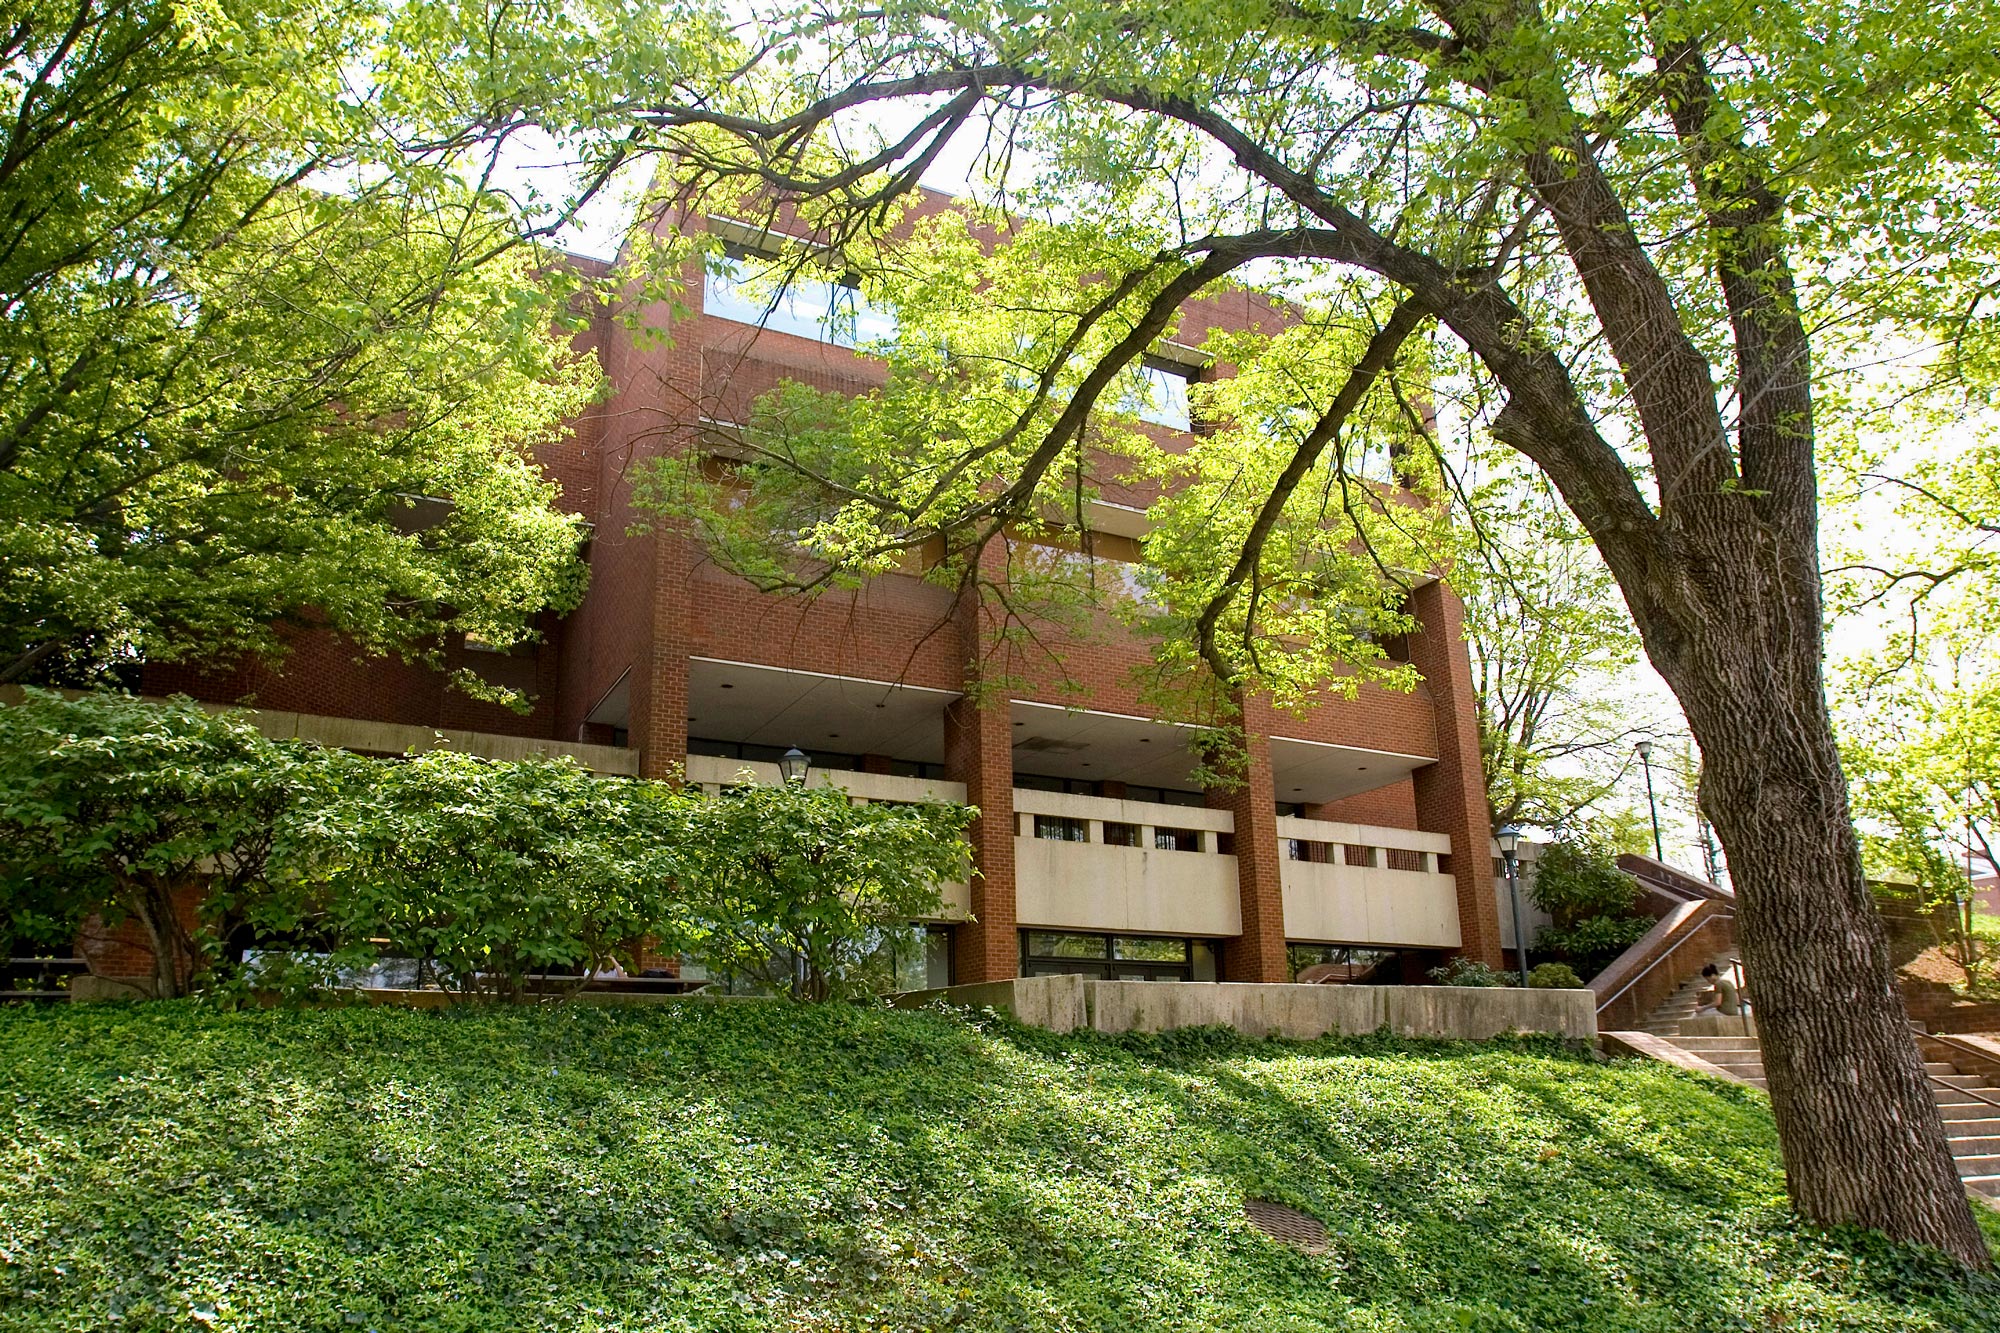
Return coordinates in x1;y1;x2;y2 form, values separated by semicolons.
0;691;332;995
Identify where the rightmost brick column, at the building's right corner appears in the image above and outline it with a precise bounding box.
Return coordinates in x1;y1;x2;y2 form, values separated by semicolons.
1410;580;1502;967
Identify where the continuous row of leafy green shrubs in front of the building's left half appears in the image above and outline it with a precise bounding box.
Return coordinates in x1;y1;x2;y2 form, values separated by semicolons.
0;691;972;1001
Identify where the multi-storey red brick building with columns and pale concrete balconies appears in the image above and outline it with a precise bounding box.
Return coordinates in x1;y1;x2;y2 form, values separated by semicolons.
144;197;1500;983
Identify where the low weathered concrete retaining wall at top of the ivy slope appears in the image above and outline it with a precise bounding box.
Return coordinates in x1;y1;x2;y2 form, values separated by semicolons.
894;977;1598;1041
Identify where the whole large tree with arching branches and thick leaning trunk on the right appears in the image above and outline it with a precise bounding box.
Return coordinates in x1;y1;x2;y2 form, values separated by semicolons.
600;0;2000;1265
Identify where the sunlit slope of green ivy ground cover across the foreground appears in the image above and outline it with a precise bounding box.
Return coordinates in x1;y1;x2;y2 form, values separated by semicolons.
0;1001;2000;1333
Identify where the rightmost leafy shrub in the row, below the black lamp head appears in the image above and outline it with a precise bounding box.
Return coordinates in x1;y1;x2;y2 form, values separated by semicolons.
678;783;976;1001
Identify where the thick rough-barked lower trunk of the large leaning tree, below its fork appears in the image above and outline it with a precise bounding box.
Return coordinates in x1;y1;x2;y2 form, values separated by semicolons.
1642;506;1990;1267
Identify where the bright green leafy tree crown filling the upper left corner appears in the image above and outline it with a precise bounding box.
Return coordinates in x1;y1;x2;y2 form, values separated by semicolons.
0;0;728;696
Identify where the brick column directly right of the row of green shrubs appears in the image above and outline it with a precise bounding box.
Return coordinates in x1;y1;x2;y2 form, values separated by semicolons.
944;697;1020;981
